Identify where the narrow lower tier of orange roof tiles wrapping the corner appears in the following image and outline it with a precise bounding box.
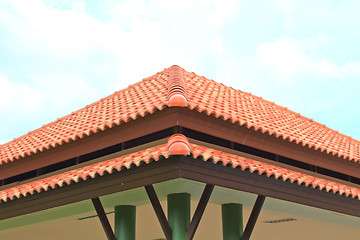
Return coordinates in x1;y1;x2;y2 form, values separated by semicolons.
0;134;360;202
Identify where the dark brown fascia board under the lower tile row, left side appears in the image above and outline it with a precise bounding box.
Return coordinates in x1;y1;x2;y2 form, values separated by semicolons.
0;157;179;220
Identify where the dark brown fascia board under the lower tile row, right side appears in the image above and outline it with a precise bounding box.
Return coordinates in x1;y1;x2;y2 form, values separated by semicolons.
179;157;360;217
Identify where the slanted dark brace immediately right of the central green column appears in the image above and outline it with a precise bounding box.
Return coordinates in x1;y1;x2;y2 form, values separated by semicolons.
186;184;214;240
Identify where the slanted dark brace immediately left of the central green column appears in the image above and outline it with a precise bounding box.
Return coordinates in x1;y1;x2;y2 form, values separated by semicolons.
145;185;172;240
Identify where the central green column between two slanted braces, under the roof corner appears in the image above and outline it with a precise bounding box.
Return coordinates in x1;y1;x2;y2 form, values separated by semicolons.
167;193;190;240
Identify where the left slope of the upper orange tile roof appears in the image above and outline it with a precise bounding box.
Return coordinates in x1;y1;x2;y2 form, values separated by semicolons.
0;70;169;164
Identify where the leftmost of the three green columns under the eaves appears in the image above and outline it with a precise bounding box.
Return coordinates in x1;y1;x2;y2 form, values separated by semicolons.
115;205;136;240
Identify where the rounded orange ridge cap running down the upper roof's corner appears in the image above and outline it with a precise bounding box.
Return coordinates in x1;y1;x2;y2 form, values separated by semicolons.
167;65;188;107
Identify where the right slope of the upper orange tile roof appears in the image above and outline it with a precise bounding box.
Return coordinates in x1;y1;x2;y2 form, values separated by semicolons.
184;72;360;162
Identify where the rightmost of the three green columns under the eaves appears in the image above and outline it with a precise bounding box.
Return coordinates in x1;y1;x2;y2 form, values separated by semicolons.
221;203;243;240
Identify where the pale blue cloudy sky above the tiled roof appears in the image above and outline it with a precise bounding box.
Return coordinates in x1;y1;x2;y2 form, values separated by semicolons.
0;0;360;144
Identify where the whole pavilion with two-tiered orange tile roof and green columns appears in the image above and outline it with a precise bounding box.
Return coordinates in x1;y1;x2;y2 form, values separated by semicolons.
0;66;360;240
